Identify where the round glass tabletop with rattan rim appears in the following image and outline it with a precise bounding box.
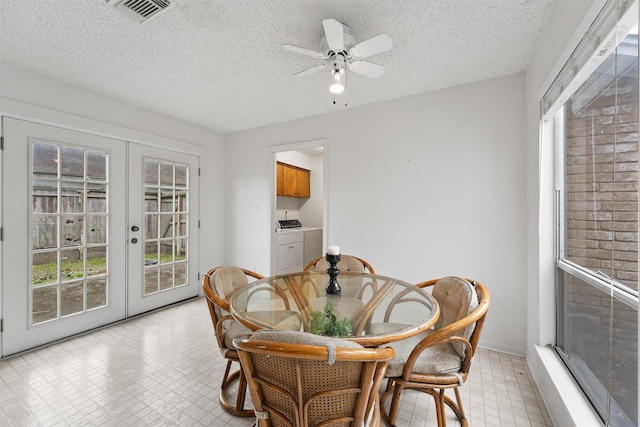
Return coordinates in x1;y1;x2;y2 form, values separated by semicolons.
230;271;440;347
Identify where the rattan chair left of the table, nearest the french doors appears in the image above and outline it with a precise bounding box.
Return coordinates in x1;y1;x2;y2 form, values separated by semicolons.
202;266;263;417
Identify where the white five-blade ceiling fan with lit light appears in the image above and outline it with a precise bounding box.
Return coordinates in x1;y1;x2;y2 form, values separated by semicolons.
282;19;393;94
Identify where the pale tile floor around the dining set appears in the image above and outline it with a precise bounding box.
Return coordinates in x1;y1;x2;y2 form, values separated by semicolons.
0;298;552;427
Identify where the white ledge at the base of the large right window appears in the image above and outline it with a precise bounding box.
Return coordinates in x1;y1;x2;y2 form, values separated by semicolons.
527;346;604;427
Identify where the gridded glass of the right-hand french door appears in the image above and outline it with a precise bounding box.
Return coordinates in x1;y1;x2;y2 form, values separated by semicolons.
144;159;189;295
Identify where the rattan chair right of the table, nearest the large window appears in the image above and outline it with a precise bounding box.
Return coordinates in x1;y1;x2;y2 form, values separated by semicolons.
381;277;491;426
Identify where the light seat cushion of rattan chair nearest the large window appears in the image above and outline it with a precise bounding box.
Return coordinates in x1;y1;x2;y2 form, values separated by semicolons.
385;331;462;377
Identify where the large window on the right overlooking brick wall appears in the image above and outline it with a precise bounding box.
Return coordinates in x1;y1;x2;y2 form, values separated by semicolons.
542;0;640;426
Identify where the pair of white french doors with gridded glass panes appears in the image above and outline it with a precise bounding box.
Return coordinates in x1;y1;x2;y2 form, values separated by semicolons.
1;118;198;355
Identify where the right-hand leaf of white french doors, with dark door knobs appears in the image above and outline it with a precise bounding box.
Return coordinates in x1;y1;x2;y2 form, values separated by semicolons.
128;144;199;315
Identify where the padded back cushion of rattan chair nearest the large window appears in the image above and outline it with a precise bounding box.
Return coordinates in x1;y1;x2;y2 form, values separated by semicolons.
432;276;478;357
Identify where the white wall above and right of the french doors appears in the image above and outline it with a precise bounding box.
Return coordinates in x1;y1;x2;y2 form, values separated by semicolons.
0;61;225;284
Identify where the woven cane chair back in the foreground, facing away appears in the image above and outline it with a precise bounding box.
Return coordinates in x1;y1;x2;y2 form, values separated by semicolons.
234;330;395;426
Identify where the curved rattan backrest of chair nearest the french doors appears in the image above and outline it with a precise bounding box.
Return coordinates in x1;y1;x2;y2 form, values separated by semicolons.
202;266;263;350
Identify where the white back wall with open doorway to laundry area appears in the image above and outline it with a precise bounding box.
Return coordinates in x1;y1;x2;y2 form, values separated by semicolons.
225;73;526;355
